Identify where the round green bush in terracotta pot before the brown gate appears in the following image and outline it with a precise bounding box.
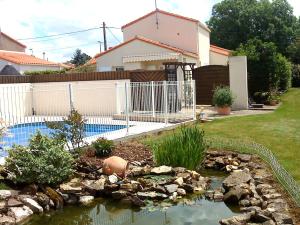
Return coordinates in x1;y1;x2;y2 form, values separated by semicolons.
213;86;233;115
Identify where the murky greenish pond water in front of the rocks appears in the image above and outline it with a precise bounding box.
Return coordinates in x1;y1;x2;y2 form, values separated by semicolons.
25;171;238;225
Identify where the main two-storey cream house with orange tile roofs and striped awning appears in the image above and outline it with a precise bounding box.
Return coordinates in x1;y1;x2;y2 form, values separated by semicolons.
95;9;230;76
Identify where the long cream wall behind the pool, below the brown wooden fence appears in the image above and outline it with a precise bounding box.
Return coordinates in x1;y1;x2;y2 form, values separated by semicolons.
33;80;129;116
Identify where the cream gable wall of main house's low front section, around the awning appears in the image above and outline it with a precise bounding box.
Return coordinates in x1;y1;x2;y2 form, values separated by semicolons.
96;40;197;71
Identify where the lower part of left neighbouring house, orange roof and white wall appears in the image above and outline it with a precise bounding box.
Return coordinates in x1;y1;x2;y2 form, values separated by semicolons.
0;50;64;74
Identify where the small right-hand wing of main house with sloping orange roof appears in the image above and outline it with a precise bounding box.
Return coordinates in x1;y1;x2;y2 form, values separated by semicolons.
209;45;231;65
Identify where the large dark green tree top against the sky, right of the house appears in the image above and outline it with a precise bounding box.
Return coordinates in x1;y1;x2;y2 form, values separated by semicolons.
207;0;297;55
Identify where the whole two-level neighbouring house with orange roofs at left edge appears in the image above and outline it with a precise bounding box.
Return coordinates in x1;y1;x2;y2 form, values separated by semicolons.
0;31;64;75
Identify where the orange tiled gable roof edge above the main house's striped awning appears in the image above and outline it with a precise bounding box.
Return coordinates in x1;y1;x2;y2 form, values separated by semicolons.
95;36;198;58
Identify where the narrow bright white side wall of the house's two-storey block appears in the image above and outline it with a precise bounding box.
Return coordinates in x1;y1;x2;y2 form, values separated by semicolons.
198;25;210;66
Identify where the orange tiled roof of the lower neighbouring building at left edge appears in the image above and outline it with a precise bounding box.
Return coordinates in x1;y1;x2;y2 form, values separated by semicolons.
0;50;59;66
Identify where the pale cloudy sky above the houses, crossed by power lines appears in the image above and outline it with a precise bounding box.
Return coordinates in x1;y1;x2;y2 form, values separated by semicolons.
0;0;300;62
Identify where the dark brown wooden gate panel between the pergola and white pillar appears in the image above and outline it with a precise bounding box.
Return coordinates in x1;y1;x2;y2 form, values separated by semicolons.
193;65;229;105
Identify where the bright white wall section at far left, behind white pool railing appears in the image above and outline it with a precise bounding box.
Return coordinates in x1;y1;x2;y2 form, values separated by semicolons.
0;83;32;125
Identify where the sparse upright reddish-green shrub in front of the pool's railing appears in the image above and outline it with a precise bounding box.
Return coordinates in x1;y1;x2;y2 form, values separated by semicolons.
46;109;86;151
